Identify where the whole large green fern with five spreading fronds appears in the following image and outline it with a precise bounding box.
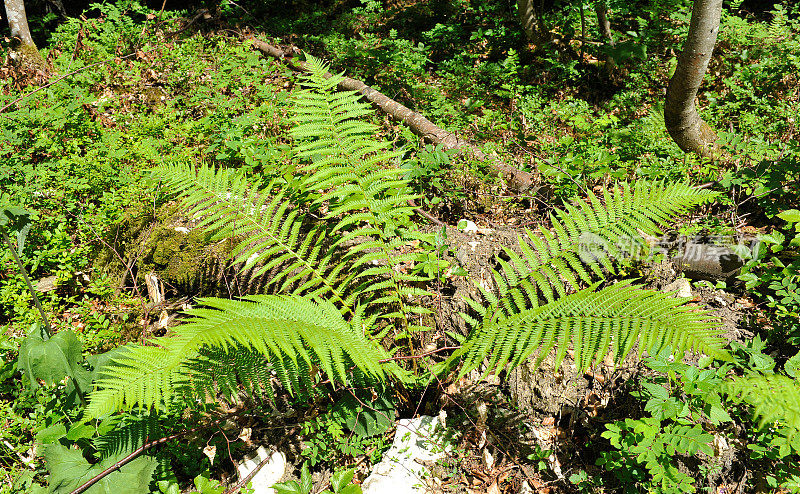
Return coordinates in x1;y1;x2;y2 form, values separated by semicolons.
89;57;725;416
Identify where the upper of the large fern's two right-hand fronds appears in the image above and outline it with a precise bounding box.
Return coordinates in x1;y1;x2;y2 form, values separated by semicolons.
480;182;716;318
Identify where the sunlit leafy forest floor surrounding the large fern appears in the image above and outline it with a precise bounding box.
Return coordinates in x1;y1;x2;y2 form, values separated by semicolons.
0;1;800;494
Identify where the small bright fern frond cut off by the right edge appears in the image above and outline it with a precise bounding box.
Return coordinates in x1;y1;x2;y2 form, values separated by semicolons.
724;374;800;453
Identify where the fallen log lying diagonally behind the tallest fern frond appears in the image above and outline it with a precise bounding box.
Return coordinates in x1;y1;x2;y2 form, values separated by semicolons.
251;38;535;193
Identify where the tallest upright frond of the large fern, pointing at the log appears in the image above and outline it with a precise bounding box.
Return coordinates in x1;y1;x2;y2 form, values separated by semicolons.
291;56;428;328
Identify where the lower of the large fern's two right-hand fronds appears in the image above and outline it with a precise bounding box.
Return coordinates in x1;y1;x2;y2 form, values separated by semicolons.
449;283;729;376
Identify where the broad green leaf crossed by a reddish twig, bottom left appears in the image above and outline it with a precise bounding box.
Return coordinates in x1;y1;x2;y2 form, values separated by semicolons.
44;443;158;494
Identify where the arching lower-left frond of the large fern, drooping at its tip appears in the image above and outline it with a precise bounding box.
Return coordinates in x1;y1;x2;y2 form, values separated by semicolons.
87;295;402;417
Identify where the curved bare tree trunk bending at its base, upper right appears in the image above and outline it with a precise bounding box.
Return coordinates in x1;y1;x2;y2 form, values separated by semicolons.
664;0;722;156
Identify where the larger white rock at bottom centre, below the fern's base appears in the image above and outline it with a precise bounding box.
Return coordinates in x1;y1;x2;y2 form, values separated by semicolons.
361;414;450;494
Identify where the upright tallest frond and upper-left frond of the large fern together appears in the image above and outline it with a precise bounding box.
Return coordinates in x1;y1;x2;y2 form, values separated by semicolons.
153;57;430;333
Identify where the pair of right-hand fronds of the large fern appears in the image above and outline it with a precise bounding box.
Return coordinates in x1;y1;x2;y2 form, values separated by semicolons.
444;183;728;375
